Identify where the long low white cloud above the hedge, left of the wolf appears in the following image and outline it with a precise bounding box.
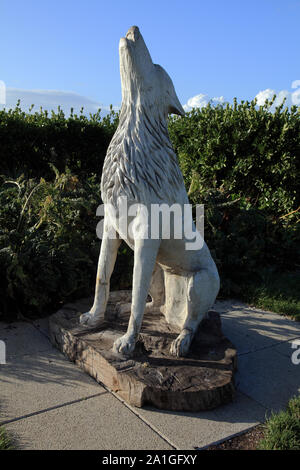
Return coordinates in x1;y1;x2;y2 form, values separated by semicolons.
2;87;117;116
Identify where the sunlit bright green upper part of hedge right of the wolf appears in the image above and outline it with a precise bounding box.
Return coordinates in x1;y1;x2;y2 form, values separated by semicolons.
169;95;300;216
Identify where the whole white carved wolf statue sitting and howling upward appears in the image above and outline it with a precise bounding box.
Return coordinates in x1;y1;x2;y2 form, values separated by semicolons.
80;26;219;356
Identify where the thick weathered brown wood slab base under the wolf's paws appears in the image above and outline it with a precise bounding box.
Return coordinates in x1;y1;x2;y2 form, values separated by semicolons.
49;291;236;411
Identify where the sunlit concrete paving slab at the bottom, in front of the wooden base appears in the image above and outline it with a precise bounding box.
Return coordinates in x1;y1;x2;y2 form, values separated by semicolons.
5;394;173;450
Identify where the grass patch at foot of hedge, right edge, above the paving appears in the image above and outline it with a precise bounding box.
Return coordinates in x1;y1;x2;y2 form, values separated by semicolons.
240;271;300;321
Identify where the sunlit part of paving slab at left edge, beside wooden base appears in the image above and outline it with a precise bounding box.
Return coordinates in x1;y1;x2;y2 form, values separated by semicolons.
0;347;105;422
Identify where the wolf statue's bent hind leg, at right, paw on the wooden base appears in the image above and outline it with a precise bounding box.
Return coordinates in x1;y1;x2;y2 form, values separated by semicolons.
170;269;220;357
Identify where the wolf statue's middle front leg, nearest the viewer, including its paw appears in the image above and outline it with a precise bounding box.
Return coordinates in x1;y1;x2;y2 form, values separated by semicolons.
113;239;160;356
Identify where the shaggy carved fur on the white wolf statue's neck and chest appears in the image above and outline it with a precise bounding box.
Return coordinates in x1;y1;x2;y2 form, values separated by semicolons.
101;102;183;204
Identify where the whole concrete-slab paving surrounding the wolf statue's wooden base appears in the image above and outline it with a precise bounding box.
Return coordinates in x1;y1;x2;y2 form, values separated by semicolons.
0;301;300;450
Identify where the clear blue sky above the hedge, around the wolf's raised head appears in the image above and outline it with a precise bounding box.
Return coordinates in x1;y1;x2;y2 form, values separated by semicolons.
0;0;300;111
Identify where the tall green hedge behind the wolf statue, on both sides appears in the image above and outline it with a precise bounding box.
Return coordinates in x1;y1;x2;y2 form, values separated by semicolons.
0;101;300;316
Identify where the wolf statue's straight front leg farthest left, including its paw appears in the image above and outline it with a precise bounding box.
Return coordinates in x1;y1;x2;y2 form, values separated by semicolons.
80;220;121;326
